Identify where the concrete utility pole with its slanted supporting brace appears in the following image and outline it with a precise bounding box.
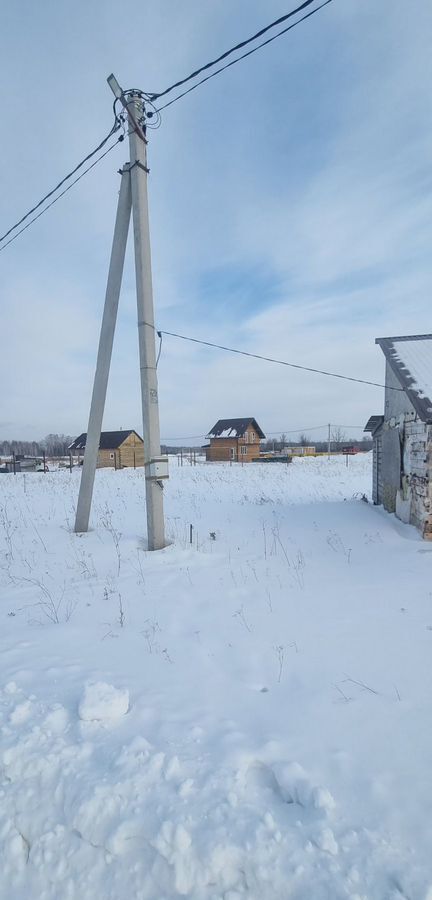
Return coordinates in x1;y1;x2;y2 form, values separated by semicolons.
75;75;168;550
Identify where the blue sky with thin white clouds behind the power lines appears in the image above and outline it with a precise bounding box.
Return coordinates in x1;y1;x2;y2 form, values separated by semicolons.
0;0;432;443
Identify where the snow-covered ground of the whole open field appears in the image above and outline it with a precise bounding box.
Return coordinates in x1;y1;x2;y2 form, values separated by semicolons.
0;455;432;900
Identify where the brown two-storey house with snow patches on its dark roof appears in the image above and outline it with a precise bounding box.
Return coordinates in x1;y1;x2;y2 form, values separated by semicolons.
205;418;265;462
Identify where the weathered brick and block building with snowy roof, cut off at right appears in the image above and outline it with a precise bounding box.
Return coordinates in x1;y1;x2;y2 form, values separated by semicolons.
364;334;432;540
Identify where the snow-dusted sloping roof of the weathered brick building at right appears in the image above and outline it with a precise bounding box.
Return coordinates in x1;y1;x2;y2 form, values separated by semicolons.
375;334;432;423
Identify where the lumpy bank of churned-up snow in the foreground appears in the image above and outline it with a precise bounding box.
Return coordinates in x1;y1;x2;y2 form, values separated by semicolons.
0;683;428;900
